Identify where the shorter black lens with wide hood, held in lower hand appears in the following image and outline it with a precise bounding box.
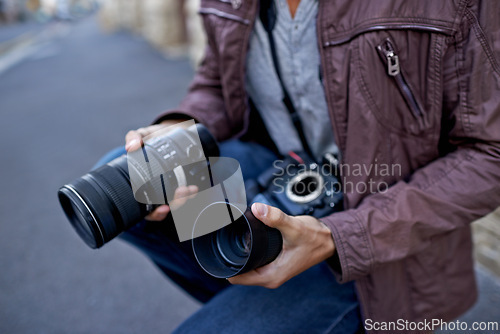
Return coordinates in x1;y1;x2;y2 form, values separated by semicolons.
192;202;283;278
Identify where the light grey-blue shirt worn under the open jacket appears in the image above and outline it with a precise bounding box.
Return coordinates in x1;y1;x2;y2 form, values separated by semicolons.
246;0;337;159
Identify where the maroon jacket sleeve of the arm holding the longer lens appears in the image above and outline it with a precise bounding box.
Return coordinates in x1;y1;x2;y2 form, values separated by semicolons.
153;21;232;140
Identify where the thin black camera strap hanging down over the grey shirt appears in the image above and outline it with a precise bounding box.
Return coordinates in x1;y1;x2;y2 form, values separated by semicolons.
259;0;314;158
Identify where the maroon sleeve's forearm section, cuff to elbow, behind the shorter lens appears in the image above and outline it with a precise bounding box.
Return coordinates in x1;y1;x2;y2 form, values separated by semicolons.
322;144;500;281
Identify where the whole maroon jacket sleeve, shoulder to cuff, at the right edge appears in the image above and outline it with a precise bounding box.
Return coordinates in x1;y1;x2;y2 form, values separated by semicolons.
322;1;500;282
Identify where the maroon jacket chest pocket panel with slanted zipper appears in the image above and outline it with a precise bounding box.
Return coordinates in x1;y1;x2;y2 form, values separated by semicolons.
346;29;442;136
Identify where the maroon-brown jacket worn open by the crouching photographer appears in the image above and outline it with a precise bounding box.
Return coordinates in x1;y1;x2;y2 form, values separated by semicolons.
154;0;500;328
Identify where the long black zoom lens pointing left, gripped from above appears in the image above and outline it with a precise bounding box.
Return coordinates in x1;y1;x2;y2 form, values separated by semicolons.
58;124;219;248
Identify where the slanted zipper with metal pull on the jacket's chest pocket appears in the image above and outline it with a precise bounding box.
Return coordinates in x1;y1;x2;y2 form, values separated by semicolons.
377;38;422;118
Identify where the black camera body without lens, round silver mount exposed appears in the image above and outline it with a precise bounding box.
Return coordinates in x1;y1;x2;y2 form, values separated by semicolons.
245;152;343;217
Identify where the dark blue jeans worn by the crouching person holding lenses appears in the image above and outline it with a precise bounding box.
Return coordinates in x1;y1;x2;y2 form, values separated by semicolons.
96;140;361;334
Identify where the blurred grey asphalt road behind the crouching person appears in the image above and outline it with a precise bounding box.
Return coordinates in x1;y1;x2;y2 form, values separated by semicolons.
0;18;500;334
